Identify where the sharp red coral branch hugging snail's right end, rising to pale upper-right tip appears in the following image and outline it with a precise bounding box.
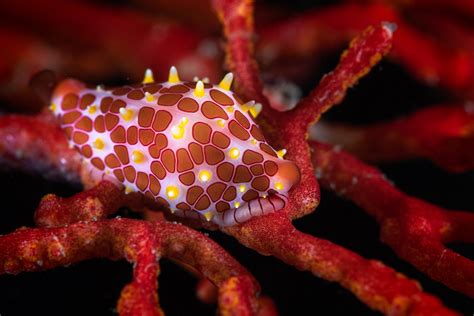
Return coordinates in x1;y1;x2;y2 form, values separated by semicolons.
273;25;393;218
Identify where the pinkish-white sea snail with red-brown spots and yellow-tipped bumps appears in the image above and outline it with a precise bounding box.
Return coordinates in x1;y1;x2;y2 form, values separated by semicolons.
50;67;300;226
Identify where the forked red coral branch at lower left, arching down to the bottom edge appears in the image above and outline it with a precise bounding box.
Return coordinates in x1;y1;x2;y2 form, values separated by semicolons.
0;219;259;315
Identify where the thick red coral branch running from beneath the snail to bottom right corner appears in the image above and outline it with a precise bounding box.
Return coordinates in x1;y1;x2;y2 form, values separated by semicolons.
226;213;455;315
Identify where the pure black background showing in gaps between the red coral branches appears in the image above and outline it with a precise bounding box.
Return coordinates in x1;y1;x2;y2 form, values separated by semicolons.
0;1;474;316
